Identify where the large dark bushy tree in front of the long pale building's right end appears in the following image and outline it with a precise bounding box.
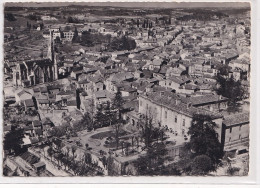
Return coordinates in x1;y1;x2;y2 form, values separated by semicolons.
177;114;223;175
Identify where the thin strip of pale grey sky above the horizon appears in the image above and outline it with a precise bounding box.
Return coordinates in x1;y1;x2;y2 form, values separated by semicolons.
5;2;250;8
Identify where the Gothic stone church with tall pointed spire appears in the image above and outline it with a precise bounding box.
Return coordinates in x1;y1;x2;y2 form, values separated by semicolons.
13;31;58;87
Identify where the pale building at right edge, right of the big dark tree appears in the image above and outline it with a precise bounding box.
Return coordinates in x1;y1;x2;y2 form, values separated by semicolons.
222;112;249;150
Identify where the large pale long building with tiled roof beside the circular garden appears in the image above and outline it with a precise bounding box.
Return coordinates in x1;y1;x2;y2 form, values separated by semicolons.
139;91;222;140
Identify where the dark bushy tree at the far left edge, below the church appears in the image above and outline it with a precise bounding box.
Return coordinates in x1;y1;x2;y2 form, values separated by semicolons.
4;129;24;155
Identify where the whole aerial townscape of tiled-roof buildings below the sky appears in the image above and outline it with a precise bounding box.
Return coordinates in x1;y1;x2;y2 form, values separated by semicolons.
2;3;251;177
